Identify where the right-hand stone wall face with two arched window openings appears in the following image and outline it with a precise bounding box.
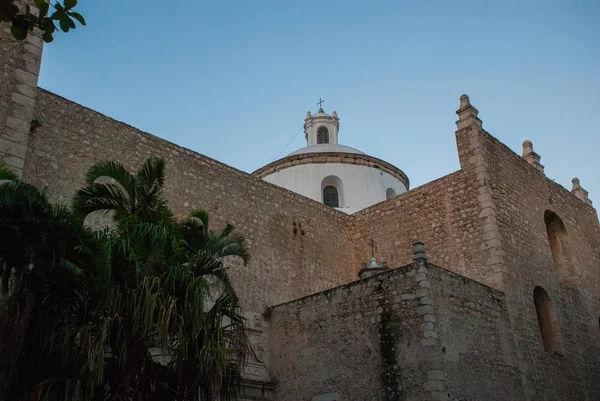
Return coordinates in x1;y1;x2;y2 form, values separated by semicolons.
480;132;600;400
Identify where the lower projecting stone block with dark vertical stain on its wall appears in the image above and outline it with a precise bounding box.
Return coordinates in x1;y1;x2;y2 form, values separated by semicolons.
270;260;522;401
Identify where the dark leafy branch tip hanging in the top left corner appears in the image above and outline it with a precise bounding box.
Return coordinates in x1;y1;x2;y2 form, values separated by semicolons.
0;0;86;43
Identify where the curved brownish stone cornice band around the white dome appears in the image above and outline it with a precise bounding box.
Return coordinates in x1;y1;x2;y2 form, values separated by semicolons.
252;152;410;190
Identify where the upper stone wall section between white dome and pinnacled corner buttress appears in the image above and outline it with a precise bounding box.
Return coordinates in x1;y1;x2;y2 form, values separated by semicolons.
352;170;494;288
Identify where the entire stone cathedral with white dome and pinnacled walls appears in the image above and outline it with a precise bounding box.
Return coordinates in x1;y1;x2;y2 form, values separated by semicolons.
0;10;600;401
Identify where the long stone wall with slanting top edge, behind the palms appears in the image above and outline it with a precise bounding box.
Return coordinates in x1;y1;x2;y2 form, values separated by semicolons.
24;89;355;313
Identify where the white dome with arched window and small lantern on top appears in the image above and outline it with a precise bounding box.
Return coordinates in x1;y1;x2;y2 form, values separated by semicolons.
252;109;409;214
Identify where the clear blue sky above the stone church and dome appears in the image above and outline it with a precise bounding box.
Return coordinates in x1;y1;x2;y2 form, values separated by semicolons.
40;0;600;200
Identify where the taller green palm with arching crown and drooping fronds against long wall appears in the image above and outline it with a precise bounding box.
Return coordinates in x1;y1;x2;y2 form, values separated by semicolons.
73;158;248;400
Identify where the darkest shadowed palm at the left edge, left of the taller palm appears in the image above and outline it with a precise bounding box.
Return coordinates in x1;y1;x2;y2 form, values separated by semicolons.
0;166;98;399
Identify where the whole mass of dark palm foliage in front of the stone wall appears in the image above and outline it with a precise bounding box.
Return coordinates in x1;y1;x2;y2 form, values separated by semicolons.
0;159;248;401
